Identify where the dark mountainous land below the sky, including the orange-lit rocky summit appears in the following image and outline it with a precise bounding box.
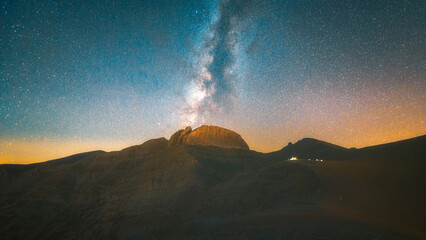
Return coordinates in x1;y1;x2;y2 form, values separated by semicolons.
0;127;426;240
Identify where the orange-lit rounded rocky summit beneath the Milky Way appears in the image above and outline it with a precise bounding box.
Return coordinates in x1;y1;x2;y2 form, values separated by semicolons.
169;125;249;150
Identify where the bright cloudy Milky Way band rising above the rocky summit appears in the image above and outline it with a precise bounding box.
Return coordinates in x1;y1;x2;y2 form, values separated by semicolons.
183;0;251;125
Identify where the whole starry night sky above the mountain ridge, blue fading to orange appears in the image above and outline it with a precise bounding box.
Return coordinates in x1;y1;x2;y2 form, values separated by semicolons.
0;0;426;163
